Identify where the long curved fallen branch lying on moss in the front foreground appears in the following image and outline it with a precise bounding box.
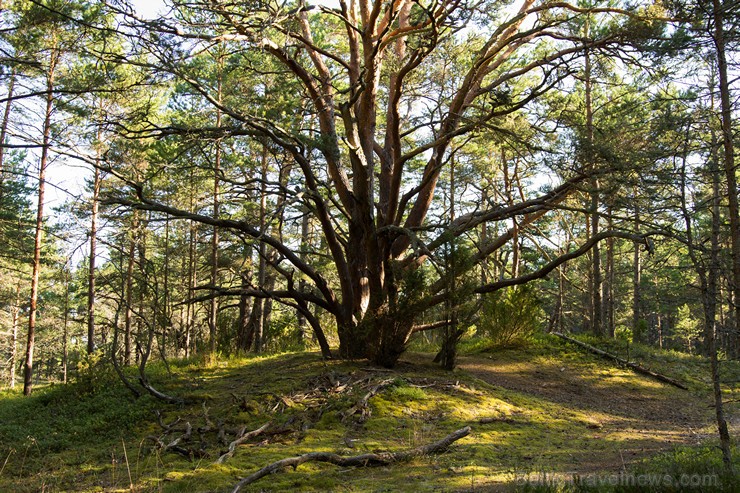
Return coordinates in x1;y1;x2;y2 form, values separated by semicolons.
231;426;470;493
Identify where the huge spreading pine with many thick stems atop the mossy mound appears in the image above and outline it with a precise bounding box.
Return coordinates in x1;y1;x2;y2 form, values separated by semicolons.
101;0;660;366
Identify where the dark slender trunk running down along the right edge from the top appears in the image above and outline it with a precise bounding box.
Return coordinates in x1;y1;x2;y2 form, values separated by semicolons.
712;0;740;357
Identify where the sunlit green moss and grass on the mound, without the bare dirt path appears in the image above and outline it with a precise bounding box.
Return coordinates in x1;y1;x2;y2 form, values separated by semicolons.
0;337;740;493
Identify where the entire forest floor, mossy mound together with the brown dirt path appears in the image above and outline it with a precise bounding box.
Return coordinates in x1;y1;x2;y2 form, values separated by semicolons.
0;337;740;492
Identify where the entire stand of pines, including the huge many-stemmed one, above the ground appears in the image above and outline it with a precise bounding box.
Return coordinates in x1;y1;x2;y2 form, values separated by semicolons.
0;0;740;472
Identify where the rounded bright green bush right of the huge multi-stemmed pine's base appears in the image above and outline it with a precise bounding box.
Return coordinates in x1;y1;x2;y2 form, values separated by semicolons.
476;286;541;348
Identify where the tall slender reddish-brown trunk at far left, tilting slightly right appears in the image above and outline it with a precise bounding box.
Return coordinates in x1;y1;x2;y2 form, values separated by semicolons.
23;50;59;395
